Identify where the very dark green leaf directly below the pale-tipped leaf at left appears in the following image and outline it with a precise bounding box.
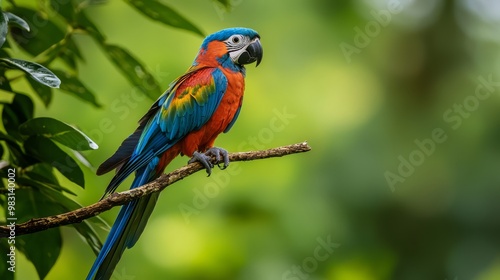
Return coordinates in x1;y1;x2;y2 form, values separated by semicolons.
24;135;85;188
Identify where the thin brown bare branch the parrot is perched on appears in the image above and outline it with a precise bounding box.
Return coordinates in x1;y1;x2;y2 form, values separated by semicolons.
0;142;311;237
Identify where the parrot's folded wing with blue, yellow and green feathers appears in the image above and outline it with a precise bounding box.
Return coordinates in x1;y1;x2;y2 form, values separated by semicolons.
100;68;227;195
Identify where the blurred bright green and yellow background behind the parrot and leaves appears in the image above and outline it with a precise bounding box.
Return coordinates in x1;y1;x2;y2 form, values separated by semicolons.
8;0;500;280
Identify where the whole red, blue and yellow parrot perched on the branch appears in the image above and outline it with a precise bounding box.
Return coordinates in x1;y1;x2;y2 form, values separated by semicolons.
86;27;263;280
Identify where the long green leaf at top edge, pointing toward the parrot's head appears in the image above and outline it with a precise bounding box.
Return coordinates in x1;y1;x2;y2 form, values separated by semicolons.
126;0;204;36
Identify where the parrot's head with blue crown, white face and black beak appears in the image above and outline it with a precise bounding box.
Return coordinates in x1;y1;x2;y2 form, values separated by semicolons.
194;27;262;71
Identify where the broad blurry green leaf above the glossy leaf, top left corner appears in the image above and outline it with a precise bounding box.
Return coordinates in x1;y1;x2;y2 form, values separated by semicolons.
10;6;65;56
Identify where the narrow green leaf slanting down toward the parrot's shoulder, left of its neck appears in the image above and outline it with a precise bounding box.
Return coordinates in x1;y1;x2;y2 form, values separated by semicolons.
103;44;162;100
